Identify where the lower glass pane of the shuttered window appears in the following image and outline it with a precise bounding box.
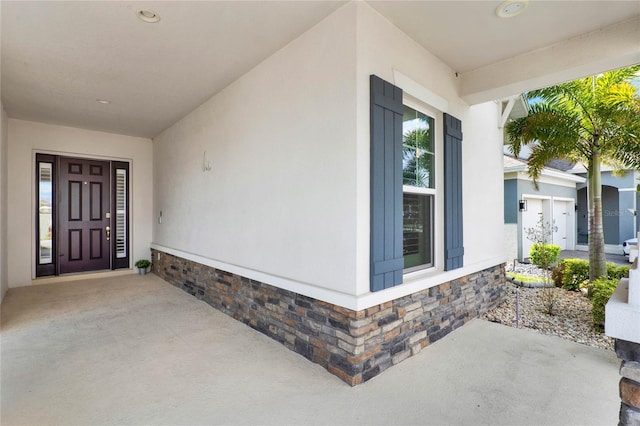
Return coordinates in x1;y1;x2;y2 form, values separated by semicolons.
402;193;433;269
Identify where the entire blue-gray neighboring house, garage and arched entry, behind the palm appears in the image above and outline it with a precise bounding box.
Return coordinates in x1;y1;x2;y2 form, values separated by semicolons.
504;147;640;261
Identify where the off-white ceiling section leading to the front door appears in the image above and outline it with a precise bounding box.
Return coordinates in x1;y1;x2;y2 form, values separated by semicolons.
1;1;342;137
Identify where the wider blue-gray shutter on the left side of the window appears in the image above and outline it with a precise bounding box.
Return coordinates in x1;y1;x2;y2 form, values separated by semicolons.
370;75;404;291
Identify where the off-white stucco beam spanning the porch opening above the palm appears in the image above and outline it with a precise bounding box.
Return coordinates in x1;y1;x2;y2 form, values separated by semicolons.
460;15;640;105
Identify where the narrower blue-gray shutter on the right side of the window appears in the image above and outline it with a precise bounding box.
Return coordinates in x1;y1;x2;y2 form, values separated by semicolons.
444;114;464;271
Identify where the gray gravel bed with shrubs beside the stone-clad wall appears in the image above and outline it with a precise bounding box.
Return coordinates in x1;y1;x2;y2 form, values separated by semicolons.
481;264;613;351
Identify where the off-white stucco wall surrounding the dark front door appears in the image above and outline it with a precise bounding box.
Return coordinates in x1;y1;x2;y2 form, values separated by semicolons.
7;118;153;287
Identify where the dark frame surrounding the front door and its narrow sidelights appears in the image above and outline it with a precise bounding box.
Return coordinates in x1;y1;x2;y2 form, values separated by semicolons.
31;150;133;279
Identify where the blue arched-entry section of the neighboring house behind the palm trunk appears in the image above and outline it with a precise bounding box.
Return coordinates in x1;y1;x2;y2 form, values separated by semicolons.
567;164;640;254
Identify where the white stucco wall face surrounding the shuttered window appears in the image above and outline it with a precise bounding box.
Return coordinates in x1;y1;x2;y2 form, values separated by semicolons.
356;3;505;307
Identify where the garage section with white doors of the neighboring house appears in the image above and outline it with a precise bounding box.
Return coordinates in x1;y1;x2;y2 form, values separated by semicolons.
504;155;585;261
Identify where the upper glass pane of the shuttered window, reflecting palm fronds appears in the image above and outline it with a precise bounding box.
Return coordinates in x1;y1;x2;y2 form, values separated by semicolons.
402;105;435;188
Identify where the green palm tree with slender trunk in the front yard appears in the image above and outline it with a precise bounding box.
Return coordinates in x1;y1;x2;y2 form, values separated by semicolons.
506;65;640;280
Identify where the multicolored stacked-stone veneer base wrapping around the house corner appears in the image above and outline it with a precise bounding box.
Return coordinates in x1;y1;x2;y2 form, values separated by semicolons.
151;249;505;386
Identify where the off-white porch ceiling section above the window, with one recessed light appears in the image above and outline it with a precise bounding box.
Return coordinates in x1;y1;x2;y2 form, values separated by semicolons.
369;0;640;73
